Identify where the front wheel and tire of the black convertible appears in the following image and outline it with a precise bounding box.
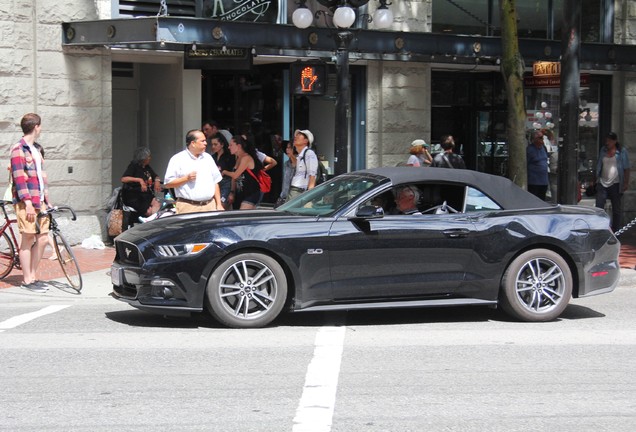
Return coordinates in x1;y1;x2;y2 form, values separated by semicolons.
206;253;287;328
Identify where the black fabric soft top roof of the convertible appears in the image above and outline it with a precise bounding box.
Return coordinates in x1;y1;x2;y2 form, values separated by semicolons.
351;167;553;210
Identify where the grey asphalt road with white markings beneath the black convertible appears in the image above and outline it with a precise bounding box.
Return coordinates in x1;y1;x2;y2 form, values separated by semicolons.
0;270;636;432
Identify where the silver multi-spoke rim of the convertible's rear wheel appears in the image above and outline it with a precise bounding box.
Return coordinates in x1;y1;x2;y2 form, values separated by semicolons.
515;258;566;313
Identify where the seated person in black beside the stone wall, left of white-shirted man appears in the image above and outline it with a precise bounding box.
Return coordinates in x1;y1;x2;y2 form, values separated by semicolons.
121;147;161;216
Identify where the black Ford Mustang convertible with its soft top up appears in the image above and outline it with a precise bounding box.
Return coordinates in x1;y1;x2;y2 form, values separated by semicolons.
111;167;620;327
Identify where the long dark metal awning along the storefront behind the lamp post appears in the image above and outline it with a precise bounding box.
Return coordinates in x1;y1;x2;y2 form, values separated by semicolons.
62;16;636;71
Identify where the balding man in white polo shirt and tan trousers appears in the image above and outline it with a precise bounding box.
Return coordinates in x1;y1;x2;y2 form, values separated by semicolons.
164;129;223;214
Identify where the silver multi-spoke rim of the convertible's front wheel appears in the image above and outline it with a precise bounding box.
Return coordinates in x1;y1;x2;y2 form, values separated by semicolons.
219;260;278;320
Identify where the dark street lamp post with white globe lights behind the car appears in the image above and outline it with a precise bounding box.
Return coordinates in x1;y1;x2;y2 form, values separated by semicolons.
292;0;393;175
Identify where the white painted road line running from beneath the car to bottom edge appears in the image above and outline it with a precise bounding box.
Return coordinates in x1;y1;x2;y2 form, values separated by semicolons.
292;327;346;432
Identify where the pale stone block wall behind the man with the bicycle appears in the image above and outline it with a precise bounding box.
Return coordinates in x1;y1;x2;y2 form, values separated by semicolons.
0;0;112;243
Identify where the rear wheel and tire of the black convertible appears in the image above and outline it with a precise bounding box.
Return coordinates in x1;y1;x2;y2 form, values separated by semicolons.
499;249;573;322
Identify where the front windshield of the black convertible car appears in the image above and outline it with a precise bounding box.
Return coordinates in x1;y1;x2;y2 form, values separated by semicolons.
277;175;381;216
